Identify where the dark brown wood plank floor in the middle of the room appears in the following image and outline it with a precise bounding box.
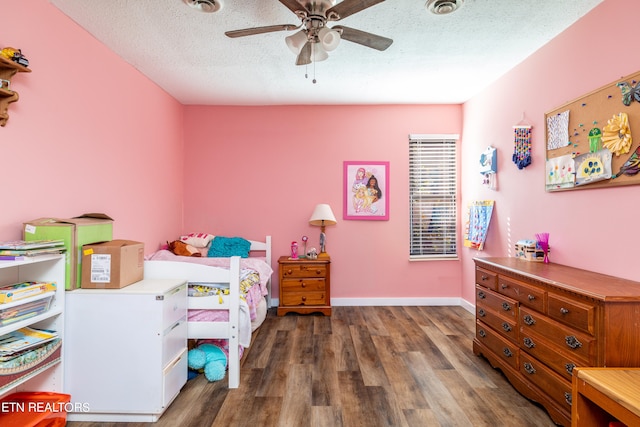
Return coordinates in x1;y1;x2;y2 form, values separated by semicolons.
68;307;555;427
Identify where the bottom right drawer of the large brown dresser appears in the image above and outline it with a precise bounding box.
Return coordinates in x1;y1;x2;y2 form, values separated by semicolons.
520;352;571;414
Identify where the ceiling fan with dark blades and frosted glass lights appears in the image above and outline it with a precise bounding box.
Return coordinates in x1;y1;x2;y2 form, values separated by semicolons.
225;0;393;65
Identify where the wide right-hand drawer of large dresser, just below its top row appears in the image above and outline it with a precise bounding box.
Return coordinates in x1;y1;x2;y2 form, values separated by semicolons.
520;307;596;365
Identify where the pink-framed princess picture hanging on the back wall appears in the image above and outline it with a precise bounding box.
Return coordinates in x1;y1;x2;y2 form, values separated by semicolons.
343;161;389;221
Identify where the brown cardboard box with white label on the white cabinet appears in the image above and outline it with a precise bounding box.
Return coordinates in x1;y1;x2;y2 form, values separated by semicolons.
82;240;144;289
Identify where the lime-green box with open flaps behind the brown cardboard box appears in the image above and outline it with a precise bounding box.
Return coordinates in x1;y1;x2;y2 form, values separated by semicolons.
23;213;113;291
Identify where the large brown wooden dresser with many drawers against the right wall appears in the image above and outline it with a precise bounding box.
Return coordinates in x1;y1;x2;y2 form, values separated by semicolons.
473;258;640;426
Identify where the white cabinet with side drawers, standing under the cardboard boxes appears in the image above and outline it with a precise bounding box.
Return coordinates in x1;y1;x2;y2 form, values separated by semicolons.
65;279;187;422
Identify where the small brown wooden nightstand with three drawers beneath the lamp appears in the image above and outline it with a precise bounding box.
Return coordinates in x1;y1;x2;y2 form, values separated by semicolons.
278;256;331;316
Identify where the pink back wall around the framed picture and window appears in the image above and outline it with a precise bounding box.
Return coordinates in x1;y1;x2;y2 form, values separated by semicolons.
185;105;462;302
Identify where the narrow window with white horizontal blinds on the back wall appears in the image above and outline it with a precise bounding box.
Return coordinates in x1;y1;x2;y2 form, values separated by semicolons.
409;135;458;259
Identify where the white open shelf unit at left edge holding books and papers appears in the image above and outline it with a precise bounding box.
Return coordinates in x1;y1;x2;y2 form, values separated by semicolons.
0;255;65;397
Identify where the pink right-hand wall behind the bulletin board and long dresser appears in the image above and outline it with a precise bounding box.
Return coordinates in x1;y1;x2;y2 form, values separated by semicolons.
462;0;640;301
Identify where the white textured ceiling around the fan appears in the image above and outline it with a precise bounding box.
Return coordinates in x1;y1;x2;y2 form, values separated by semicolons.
50;0;602;105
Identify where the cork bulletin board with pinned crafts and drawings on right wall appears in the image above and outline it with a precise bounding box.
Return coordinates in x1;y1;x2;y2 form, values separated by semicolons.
545;72;640;191
